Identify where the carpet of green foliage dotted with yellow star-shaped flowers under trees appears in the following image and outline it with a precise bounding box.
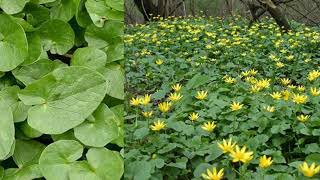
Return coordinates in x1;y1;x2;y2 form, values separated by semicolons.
125;16;320;180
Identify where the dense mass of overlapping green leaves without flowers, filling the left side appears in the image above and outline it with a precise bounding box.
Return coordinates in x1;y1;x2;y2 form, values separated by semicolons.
0;0;124;180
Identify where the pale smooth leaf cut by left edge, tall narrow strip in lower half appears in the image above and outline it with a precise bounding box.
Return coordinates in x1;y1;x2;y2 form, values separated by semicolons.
0;98;14;160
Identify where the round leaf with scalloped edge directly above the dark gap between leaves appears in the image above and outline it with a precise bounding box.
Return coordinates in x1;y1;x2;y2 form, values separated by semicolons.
39;19;75;54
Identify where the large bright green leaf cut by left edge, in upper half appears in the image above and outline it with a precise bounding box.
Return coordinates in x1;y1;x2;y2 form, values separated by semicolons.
0;14;28;71
